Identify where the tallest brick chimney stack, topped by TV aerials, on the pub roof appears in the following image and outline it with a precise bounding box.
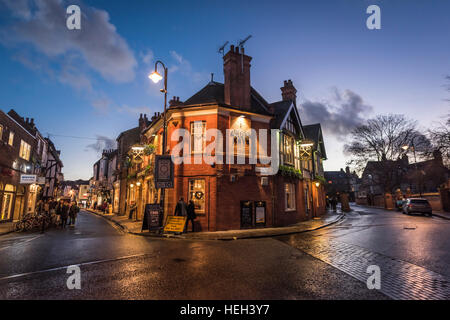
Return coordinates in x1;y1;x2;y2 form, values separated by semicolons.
223;45;252;110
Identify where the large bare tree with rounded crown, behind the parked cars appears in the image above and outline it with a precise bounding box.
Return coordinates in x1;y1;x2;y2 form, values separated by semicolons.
345;114;430;191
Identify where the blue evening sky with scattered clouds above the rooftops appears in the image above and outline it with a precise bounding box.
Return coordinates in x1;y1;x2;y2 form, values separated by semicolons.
0;0;450;179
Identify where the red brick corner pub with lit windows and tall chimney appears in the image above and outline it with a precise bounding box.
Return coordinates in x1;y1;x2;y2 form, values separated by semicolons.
127;46;326;231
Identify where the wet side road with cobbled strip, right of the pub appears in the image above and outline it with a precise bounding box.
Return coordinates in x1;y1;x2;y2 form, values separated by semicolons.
278;206;450;300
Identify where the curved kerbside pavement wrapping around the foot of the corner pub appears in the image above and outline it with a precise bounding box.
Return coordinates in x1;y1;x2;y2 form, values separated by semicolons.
85;209;344;240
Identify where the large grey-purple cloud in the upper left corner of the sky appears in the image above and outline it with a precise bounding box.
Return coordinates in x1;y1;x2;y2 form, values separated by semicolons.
0;0;137;83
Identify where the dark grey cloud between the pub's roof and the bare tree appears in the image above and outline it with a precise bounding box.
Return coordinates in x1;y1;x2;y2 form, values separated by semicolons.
300;89;373;138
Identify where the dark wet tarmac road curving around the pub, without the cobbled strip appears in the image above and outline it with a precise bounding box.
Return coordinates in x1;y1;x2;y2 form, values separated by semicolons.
0;211;450;299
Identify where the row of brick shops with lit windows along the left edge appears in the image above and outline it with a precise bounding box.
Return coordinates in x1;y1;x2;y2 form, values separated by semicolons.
0;109;63;223
